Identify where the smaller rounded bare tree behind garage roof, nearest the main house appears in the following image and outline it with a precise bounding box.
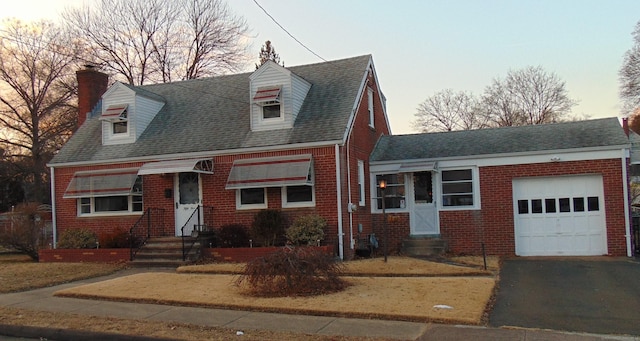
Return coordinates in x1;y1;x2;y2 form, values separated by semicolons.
413;89;486;132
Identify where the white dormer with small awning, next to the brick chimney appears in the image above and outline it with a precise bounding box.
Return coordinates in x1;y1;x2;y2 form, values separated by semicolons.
100;82;164;145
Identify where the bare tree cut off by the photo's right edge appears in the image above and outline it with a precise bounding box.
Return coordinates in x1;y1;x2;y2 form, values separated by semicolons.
618;21;640;115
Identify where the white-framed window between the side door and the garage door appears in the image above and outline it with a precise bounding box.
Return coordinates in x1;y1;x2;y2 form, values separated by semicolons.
441;169;476;207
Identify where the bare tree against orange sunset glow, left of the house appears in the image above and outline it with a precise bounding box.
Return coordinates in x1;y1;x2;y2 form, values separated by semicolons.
0;20;77;202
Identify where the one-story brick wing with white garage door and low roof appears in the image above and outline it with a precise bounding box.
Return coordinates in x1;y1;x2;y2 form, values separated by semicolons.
369;118;632;256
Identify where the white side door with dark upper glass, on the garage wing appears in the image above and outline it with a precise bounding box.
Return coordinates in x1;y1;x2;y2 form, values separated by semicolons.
409;171;440;235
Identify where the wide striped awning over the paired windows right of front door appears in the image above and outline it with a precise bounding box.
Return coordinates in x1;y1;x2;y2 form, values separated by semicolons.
225;154;313;189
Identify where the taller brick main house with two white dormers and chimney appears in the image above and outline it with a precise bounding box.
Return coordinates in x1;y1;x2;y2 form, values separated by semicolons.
49;55;390;259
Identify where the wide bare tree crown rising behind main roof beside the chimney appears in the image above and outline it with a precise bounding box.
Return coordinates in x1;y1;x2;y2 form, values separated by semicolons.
63;0;248;85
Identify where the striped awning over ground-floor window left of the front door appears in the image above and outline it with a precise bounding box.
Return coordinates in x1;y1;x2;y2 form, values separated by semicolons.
63;168;138;198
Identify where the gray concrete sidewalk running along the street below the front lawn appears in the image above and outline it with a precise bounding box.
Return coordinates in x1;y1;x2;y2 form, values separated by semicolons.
0;269;640;341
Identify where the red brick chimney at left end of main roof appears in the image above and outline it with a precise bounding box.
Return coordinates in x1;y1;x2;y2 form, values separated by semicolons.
76;65;109;128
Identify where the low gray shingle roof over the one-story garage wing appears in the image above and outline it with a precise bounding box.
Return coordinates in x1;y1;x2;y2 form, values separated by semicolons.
370;117;629;162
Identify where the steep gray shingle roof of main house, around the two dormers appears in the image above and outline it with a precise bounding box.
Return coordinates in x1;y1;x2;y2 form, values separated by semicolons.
50;55;371;164
